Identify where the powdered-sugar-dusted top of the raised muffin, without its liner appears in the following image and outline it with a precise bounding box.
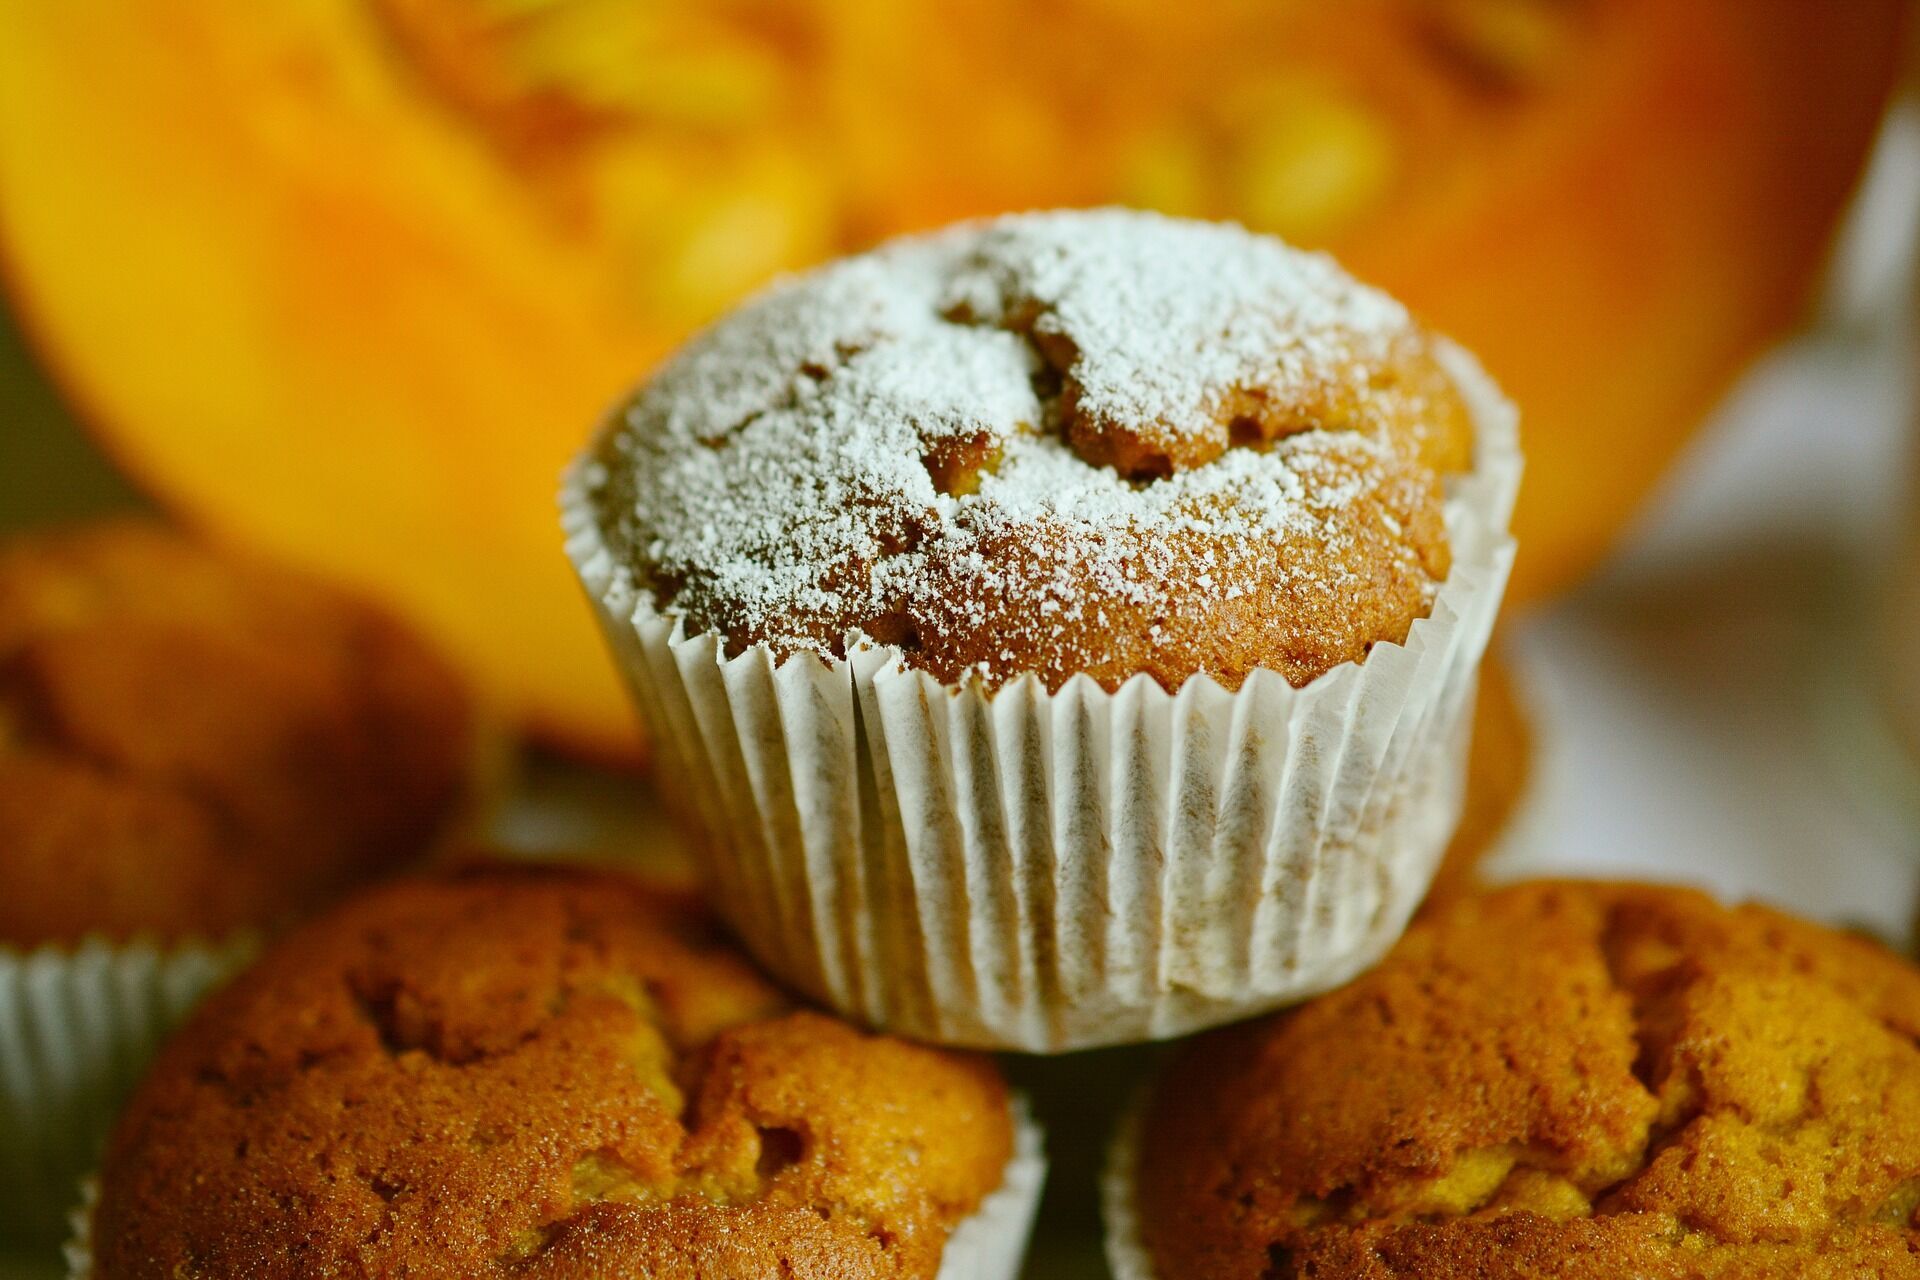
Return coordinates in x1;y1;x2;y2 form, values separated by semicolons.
586;209;1473;689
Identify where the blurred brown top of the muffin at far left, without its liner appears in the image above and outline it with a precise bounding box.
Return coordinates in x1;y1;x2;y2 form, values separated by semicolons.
0;522;474;946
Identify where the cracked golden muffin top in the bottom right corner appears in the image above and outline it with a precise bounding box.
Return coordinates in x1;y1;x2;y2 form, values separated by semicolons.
1137;883;1920;1280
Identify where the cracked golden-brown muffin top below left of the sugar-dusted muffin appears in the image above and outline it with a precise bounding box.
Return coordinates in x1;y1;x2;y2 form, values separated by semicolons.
94;867;1012;1280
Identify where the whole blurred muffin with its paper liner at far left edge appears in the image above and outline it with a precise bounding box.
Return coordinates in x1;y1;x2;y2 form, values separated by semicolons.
0;522;474;1232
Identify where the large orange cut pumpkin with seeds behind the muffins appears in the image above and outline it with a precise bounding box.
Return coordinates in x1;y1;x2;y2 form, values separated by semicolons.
0;0;1903;750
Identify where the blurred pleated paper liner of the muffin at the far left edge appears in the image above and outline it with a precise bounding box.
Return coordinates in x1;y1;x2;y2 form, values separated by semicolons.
0;936;253;1240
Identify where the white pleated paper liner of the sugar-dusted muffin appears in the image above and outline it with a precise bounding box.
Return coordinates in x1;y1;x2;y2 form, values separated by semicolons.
561;339;1521;1052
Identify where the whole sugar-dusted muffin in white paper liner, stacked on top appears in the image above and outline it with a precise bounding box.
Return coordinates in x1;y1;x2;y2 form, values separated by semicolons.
563;209;1519;1050
